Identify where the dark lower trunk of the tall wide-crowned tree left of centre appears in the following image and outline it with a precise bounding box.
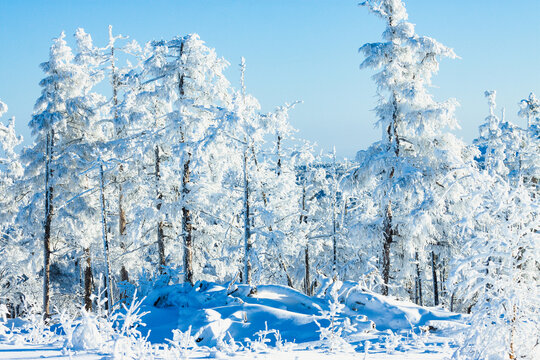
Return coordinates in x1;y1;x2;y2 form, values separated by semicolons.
182;152;194;285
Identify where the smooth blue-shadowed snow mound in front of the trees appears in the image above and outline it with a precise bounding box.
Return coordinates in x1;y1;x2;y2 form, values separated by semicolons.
140;282;462;347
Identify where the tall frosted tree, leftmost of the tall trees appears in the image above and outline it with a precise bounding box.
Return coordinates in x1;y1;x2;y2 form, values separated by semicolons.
19;32;103;317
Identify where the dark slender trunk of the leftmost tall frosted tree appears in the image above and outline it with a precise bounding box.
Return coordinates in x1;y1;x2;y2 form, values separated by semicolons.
43;129;54;320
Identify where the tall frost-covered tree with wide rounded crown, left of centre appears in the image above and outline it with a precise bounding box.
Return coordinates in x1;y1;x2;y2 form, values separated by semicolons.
130;35;233;283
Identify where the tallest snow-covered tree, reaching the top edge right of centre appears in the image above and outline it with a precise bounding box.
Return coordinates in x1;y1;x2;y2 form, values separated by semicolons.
356;0;471;303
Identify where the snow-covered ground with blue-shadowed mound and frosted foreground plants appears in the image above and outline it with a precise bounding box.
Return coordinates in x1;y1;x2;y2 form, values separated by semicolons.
0;282;466;360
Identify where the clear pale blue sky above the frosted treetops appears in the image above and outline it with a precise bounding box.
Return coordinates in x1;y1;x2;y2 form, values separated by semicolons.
0;0;540;157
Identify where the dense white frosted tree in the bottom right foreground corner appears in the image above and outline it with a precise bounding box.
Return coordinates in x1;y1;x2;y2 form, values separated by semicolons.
452;174;540;359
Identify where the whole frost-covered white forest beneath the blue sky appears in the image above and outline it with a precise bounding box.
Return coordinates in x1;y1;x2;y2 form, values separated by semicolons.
0;0;540;359
